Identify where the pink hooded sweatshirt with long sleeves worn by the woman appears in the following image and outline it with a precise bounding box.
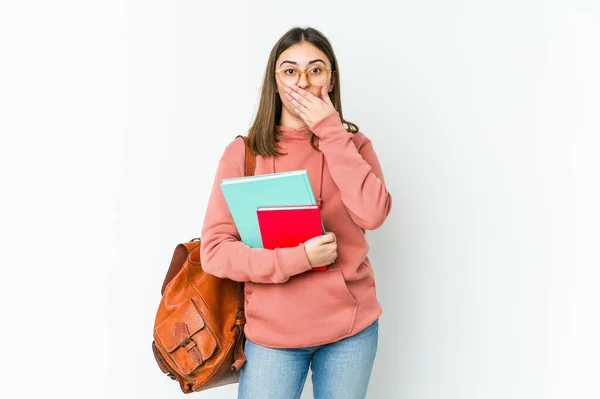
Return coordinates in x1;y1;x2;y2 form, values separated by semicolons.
201;113;391;348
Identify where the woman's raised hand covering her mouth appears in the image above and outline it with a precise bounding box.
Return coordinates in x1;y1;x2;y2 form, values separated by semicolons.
284;85;336;129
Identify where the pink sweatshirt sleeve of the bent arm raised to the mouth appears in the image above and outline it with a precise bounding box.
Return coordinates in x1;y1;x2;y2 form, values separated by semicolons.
312;112;392;230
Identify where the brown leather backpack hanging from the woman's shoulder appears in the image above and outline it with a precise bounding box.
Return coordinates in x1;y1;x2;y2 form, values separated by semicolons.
152;136;256;393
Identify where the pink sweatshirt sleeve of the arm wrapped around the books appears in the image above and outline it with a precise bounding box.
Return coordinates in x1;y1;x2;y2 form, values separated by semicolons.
200;139;311;283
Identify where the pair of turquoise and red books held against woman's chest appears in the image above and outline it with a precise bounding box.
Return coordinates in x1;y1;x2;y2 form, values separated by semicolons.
221;170;327;270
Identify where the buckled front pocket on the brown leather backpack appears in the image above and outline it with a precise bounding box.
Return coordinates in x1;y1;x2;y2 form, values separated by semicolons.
154;299;217;374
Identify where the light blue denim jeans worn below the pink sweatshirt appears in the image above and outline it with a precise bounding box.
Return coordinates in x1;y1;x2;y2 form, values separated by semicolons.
238;320;379;399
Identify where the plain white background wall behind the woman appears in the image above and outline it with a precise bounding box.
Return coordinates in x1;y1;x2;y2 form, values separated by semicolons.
0;0;600;399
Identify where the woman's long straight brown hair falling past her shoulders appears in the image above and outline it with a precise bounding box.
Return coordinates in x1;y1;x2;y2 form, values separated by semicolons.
248;27;358;156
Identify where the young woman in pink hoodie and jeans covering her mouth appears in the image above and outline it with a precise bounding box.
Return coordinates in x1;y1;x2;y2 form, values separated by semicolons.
201;28;391;399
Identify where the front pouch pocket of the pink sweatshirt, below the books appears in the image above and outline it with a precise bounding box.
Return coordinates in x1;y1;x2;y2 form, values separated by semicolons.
247;269;358;347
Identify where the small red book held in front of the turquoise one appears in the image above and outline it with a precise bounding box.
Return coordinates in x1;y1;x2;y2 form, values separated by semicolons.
256;205;327;271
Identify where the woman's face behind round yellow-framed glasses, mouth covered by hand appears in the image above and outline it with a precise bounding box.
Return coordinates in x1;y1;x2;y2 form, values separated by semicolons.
275;42;333;120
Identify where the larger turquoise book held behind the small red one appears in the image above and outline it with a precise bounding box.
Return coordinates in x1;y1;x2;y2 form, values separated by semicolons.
221;170;317;248
